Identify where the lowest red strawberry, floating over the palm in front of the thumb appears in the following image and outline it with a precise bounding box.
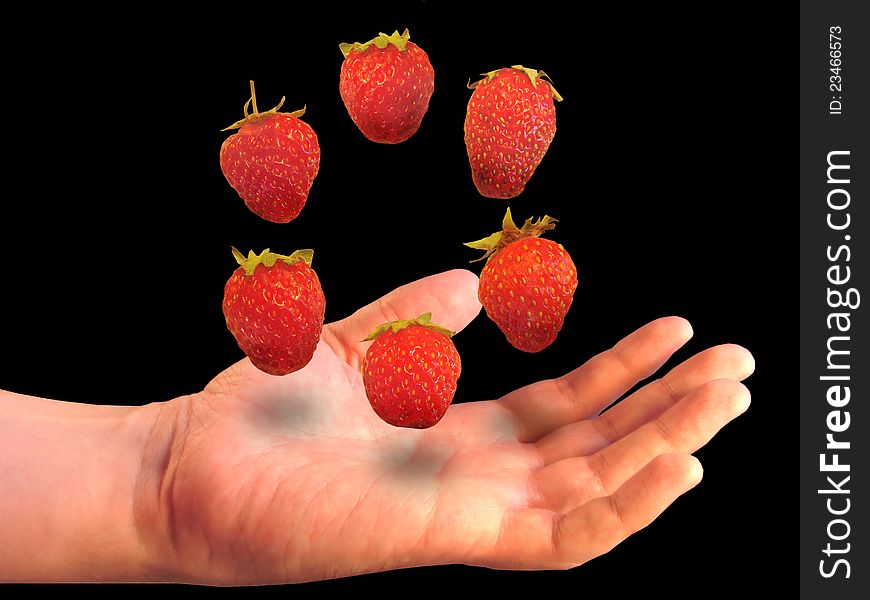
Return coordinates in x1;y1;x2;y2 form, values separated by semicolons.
362;313;462;429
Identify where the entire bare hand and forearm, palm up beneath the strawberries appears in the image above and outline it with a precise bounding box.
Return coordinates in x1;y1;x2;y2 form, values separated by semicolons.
0;270;754;585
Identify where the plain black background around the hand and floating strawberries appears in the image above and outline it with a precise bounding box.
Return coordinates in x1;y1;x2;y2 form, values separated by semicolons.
0;2;797;598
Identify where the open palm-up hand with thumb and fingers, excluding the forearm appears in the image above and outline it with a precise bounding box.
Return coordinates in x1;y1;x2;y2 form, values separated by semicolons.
136;270;753;584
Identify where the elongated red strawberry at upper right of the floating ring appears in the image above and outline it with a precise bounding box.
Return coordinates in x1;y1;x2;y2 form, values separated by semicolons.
465;65;562;198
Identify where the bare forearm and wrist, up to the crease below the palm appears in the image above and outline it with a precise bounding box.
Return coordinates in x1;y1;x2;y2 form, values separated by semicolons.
0;392;191;581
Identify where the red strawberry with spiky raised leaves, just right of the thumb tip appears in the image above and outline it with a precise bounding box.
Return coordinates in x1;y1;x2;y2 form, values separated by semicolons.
465;209;577;352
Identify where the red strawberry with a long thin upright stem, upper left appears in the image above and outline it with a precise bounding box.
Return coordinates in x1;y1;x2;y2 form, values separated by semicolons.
221;81;320;223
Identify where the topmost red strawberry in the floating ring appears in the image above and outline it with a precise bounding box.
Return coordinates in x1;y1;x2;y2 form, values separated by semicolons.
339;29;435;144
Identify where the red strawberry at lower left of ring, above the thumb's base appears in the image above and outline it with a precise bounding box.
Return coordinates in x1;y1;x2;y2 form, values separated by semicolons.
223;248;326;375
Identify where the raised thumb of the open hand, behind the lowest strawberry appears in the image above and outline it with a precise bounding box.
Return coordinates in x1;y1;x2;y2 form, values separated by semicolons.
324;269;480;366
